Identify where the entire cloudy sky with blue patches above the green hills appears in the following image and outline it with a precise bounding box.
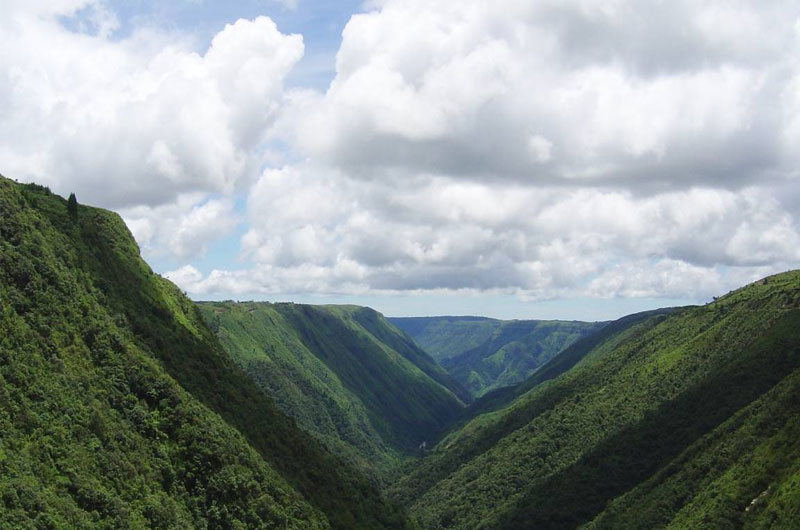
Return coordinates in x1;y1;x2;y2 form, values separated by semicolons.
0;0;800;320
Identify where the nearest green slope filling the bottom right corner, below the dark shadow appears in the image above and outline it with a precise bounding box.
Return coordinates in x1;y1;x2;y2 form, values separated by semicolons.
586;370;800;530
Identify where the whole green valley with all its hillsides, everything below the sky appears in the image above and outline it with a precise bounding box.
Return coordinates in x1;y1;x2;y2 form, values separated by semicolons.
0;177;800;530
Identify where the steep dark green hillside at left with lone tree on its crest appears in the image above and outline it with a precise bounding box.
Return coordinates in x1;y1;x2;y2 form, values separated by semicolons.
0;178;403;528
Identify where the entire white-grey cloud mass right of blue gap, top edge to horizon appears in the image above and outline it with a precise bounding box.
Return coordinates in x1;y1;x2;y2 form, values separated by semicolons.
202;0;800;299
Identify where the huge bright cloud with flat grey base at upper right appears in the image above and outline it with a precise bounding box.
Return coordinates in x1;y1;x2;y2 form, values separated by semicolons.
284;0;798;188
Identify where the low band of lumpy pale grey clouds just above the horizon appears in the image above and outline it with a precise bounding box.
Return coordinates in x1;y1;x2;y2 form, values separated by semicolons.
173;165;800;300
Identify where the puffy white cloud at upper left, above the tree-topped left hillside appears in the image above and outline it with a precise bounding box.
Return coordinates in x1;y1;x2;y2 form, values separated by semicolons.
0;0;303;208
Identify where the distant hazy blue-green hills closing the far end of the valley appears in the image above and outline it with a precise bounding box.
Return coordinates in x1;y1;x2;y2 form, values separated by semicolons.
390;317;605;397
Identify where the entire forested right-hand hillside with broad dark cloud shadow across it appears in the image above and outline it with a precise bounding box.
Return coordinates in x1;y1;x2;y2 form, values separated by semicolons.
393;272;800;529
